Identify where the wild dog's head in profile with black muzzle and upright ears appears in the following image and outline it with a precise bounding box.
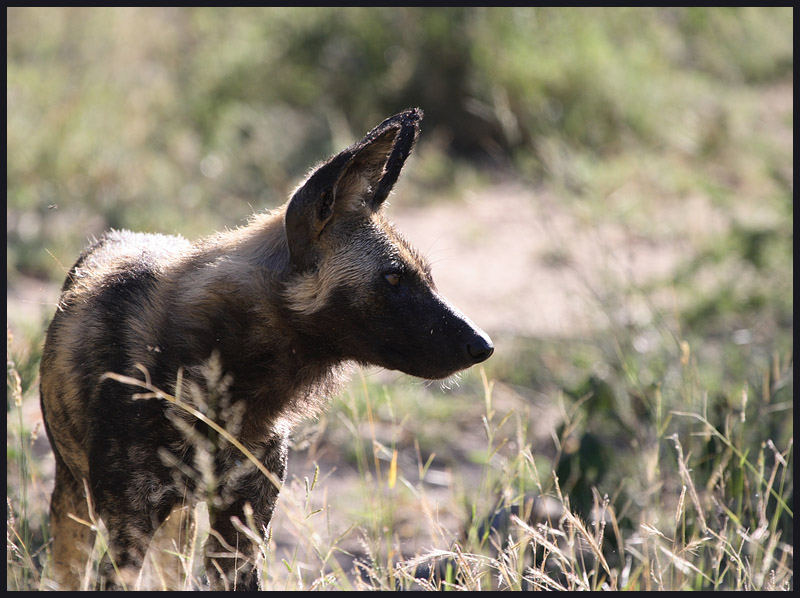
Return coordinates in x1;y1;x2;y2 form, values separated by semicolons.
285;109;494;378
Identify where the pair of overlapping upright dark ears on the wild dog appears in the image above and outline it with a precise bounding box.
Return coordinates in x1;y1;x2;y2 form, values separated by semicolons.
285;108;422;272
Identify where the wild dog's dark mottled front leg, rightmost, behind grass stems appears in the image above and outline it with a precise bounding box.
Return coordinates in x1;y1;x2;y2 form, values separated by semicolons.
205;437;288;590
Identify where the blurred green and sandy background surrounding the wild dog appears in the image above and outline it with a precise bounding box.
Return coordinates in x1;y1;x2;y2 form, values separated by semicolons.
6;7;793;589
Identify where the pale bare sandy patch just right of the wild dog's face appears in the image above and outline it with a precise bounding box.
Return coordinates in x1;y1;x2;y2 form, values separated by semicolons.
391;184;682;337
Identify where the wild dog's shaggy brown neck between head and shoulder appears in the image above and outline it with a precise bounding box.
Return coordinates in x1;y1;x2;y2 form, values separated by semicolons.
168;210;339;436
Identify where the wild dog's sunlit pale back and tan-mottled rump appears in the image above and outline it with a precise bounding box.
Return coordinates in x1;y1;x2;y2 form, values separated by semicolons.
40;231;191;479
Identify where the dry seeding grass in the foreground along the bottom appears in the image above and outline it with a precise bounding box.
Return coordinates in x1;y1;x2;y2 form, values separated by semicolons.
7;332;793;590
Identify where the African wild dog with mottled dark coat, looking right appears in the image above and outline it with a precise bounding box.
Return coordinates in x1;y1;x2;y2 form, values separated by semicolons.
41;109;493;589
